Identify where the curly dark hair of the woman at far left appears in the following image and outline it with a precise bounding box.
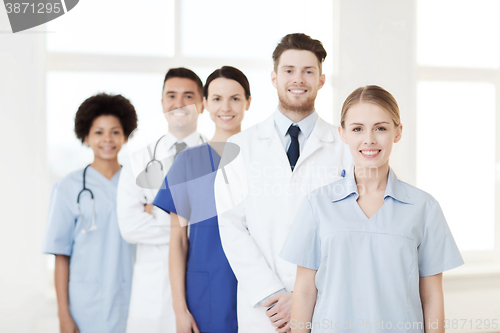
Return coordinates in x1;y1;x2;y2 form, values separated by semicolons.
75;93;137;143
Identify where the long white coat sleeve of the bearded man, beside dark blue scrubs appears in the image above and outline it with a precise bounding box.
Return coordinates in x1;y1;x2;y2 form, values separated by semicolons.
215;139;285;306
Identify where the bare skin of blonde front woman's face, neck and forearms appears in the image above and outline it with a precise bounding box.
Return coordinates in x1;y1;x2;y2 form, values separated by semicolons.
292;102;444;333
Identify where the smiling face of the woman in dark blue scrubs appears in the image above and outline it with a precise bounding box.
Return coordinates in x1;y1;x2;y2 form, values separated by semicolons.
203;77;251;132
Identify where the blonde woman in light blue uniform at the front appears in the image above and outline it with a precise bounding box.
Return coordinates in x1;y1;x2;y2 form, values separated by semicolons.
280;86;463;333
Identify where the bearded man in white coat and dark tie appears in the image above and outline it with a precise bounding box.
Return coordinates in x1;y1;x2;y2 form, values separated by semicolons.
215;34;352;333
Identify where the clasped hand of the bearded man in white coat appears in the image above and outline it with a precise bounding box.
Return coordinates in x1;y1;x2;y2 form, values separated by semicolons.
262;291;293;333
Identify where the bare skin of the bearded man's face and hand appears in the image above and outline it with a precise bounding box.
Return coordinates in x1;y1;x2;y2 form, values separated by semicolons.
262;50;325;332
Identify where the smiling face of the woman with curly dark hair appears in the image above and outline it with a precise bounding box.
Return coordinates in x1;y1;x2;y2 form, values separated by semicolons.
85;115;126;161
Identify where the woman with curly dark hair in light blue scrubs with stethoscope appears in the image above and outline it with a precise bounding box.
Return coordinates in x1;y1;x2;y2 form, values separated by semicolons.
43;94;137;333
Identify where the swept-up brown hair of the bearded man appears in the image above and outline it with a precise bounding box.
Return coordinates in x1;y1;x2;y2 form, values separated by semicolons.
273;33;326;73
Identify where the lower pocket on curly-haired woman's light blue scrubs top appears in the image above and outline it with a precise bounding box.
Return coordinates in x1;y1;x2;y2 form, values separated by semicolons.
68;281;104;332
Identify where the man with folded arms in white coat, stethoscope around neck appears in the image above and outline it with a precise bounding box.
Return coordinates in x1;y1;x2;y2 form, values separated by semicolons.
117;68;206;333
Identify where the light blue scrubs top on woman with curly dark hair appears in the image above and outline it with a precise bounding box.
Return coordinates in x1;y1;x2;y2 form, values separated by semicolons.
43;167;134;333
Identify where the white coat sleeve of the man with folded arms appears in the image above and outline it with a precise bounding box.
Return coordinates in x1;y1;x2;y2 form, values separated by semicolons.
117;155;170;245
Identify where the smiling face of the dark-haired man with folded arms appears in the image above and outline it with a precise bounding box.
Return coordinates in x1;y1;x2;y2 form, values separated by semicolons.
161;77;203;133
